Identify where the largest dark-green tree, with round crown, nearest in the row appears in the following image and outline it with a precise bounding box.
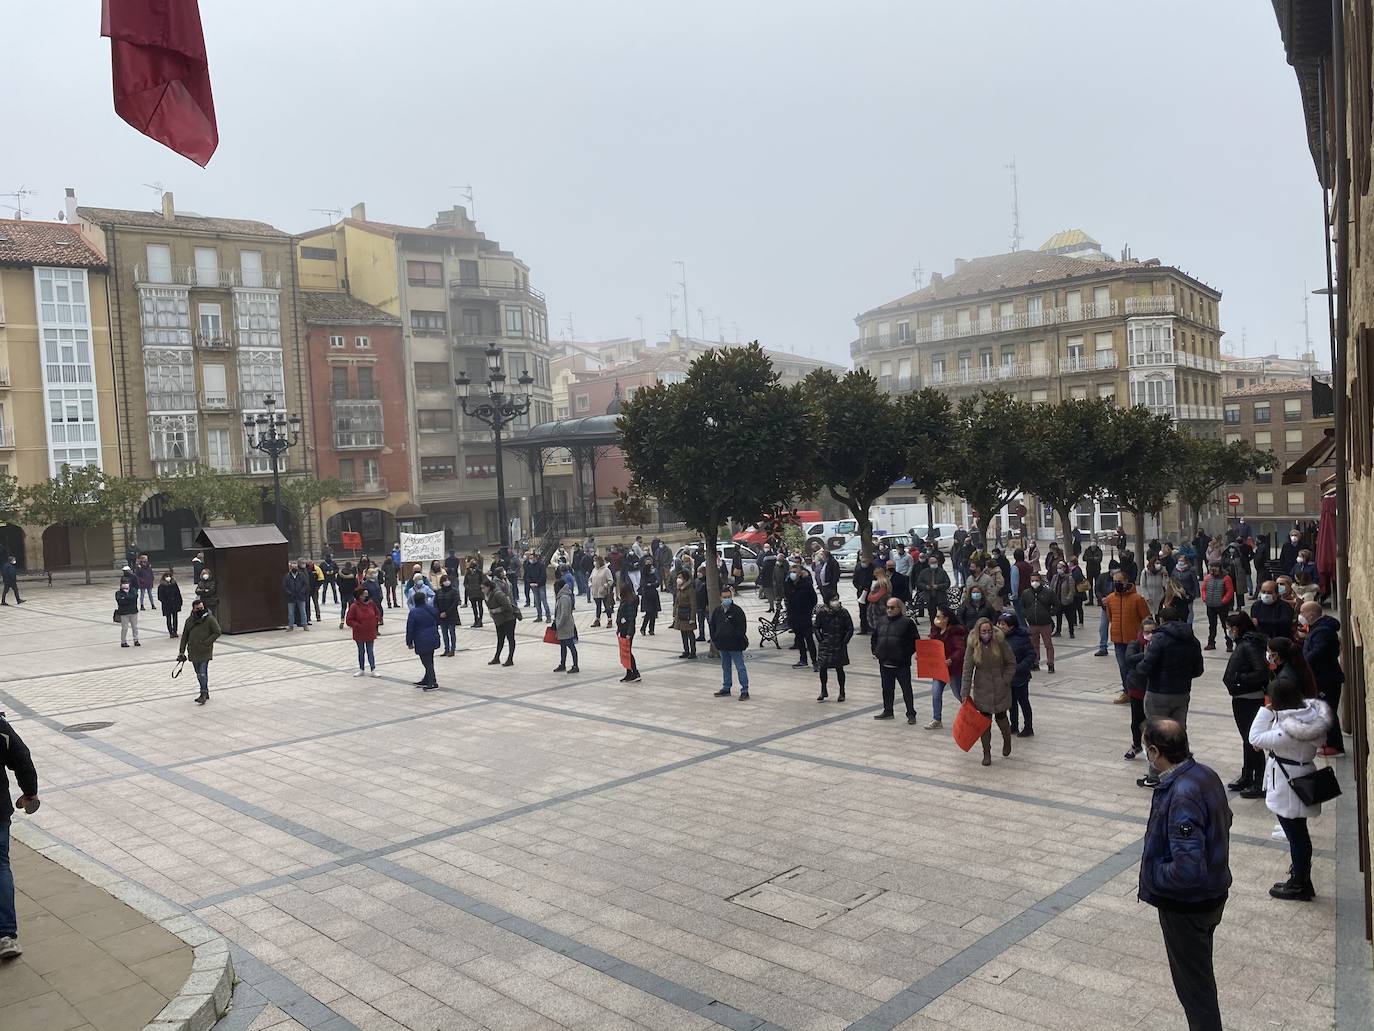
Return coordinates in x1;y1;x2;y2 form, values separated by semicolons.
617;341;818;621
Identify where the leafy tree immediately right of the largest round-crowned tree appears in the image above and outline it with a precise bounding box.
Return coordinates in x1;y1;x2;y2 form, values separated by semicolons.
804;368;910;555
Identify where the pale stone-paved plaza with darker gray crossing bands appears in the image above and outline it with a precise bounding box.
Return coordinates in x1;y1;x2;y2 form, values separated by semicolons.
0;586;1362;1031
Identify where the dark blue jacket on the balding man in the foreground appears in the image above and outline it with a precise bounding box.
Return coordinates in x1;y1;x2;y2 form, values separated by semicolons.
1138;756;1231;911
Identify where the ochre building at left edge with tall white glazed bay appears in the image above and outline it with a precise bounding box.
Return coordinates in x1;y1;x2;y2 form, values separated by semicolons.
0;220;120;569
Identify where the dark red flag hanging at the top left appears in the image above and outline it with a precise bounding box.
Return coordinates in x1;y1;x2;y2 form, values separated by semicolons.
100;0;220;166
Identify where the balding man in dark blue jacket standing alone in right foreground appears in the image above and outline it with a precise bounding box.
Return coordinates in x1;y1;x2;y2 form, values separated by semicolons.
1139;719;1231;1031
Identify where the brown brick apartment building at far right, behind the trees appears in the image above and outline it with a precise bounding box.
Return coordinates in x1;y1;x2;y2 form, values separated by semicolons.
1221;379;1334;540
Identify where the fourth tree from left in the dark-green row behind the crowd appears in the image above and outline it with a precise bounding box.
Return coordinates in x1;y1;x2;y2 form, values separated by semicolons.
949;390;1040;544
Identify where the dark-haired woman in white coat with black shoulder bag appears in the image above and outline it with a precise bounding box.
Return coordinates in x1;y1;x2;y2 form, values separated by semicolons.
1250;638;1331;902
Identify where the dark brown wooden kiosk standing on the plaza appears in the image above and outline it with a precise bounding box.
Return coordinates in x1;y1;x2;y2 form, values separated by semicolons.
195;524;290;634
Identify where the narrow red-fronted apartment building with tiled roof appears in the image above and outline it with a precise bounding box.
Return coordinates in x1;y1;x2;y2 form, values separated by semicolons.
301;290;412;553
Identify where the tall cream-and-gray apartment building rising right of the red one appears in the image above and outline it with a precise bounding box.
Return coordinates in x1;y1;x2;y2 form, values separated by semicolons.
297;203;554;547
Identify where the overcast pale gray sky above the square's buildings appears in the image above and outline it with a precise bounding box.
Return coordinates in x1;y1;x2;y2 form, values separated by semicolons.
0;0;1326;364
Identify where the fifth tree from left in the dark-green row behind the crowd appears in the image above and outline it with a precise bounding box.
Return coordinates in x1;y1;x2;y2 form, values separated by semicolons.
1018;397;1117;544
